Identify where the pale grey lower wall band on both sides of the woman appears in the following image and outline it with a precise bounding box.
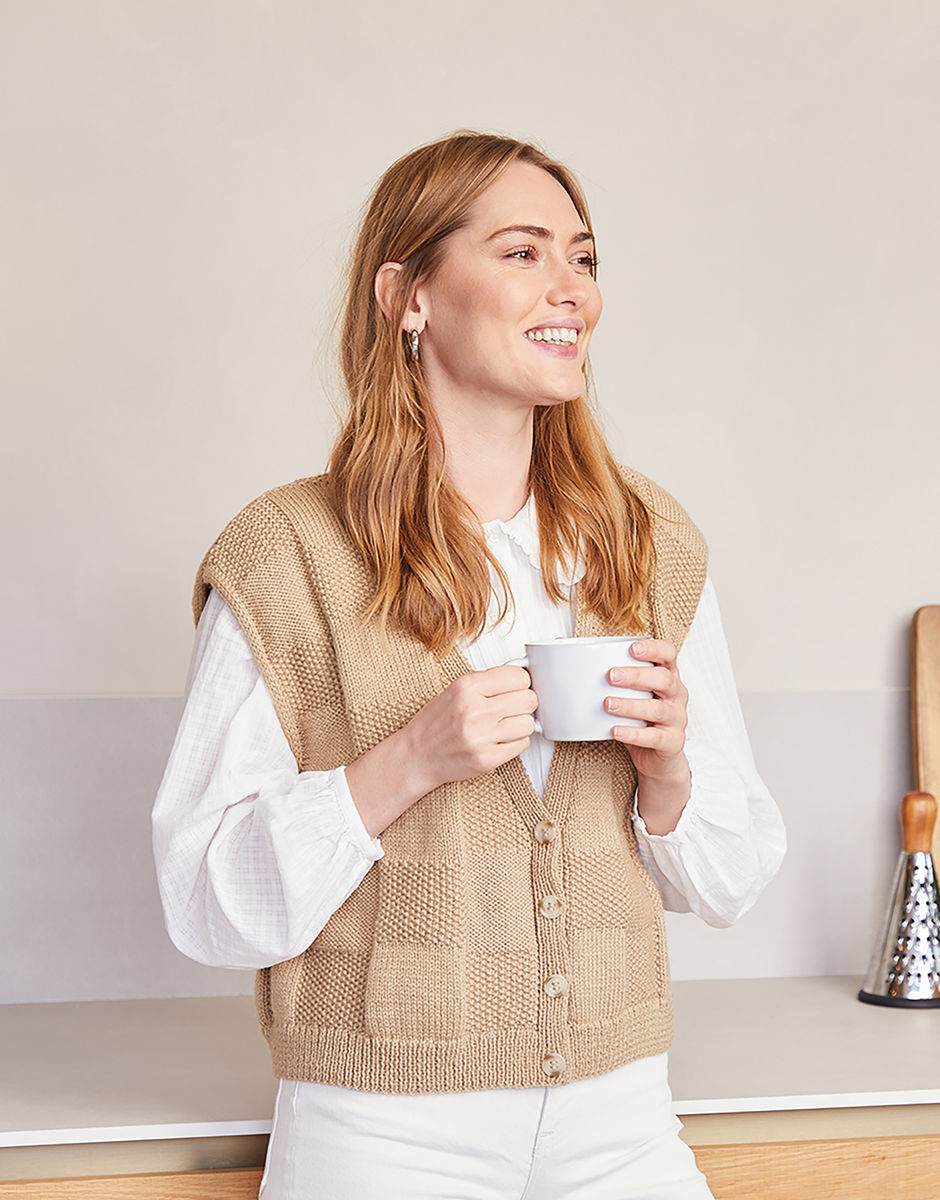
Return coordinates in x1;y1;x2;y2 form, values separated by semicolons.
0;691;910;1003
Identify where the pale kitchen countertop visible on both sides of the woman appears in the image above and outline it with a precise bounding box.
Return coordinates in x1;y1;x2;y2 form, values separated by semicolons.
0;976;940;1147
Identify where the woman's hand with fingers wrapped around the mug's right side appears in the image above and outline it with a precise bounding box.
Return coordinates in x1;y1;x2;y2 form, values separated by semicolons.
604;637;689;782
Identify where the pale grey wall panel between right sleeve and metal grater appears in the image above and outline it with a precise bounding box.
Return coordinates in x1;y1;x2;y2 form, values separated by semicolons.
666;690;911;979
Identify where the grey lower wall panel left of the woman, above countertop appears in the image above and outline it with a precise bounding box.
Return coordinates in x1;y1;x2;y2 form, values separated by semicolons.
0;698;253;1003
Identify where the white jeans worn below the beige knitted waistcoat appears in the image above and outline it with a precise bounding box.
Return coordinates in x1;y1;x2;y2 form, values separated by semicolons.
261;1055;711;1200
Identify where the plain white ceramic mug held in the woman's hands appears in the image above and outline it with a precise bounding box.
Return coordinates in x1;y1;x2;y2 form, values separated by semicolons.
511;637;653;742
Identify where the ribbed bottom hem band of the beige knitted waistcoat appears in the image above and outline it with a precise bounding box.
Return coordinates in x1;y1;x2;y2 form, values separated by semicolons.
268;997;672;1093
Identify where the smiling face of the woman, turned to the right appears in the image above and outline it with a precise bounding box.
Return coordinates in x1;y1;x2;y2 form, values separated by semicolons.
406;162;601;420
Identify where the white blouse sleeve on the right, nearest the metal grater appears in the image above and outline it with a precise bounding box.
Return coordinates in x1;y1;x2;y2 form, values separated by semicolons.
634;580;786;926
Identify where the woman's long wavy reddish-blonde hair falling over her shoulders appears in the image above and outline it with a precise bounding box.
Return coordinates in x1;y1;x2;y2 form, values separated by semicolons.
329;131;653;650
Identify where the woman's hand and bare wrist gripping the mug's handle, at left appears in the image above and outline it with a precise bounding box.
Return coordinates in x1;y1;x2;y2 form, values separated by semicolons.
346;666;538;838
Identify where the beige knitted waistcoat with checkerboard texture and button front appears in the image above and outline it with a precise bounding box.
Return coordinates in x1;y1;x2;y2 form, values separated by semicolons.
193;472;706;1092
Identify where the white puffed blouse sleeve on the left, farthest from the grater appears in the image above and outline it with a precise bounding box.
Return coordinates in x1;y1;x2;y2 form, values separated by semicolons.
152;590;382;968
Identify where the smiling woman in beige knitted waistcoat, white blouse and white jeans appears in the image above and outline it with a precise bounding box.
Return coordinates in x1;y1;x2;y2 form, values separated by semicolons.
154;133;784;1200
